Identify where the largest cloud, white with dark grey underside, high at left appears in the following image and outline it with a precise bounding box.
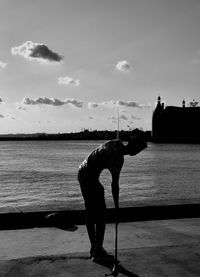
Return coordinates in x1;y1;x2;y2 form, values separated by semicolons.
11;41;63;63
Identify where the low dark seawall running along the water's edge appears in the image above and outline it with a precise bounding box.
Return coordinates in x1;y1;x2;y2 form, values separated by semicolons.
0;201;200;230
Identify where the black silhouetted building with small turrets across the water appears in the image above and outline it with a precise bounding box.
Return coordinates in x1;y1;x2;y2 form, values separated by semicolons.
152;96;200;139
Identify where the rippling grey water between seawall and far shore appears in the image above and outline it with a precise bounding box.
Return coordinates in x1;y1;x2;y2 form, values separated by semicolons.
0;141;200;211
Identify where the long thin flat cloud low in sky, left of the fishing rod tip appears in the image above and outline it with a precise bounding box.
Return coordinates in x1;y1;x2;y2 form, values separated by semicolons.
22;97;83;108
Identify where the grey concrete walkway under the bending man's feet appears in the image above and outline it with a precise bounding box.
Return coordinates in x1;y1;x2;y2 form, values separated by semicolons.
0;218;200;277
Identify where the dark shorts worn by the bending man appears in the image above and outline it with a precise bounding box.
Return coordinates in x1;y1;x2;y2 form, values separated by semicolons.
78;168;106;223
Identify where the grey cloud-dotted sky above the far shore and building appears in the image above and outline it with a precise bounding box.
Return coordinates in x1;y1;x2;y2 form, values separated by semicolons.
0;0;200;134
